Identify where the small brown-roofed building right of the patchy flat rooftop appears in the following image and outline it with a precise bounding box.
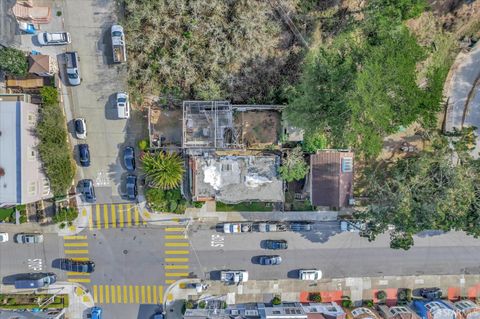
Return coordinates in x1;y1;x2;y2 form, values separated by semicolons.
310;150;353;208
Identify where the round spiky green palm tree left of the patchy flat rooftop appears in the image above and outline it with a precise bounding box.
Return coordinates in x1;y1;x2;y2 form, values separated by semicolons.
142;152;185;189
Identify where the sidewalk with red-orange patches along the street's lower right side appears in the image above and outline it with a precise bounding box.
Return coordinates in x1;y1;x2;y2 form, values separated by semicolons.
165;275;480;318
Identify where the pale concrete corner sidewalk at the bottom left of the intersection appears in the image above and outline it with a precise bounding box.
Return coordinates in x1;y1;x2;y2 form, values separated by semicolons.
0;282;94;319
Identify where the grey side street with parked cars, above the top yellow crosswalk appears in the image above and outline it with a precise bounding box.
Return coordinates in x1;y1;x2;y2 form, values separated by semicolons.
64;0;146;203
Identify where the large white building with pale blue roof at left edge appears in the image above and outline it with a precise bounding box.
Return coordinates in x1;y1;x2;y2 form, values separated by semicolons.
0;95;51;206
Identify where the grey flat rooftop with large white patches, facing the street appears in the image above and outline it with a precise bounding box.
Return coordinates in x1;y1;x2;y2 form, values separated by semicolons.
190;155;284;204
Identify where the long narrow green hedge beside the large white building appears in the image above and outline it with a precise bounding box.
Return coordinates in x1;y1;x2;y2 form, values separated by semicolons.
37;86;76;196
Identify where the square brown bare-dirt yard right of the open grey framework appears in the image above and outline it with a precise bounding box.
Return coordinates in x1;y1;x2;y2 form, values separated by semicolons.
235;111;282;148
